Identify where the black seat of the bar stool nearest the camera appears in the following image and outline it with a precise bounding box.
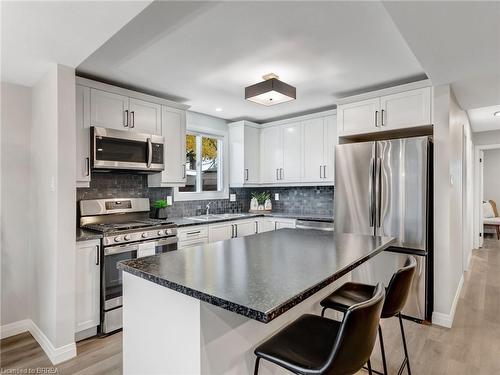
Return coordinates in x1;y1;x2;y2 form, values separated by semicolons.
255;314;341;373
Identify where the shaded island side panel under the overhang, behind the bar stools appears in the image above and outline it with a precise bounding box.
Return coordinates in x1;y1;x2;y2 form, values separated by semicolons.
200;273;351;375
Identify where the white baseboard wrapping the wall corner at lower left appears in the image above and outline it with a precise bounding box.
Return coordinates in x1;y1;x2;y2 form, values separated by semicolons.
0;319;76;365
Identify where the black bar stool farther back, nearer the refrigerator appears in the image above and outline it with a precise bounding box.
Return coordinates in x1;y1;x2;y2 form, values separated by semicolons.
320;256;417;375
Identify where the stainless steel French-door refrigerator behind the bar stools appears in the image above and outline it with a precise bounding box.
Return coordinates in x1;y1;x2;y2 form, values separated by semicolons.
334;137;433;321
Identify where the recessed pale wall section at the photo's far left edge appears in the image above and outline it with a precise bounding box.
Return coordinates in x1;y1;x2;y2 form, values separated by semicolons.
0;82;33;325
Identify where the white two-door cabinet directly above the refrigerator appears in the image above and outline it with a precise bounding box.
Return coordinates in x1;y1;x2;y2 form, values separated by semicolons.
337;87;432;136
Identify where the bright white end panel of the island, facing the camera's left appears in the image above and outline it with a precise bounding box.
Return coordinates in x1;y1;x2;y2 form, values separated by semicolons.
123;272;201;375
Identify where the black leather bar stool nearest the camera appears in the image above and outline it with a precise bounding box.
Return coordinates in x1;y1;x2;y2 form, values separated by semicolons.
254;283;385;375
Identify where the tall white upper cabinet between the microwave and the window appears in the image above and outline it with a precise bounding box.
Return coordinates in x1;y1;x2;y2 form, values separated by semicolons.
148;106;186;187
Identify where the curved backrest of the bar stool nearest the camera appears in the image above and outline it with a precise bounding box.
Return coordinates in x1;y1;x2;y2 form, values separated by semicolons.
321;283;385;374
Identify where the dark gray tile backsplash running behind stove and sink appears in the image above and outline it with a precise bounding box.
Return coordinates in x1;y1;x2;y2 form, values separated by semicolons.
77;172;334;217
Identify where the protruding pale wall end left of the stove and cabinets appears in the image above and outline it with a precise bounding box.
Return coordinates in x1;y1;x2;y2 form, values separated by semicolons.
31;65;76;358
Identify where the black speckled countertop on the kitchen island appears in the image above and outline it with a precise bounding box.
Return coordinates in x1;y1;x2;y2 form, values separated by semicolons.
118;229;394;323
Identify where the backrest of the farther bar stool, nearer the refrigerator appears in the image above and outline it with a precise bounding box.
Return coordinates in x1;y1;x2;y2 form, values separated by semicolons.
382;256;417;318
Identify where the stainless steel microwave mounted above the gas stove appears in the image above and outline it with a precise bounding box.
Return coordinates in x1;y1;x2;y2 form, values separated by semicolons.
90;126;164;173
